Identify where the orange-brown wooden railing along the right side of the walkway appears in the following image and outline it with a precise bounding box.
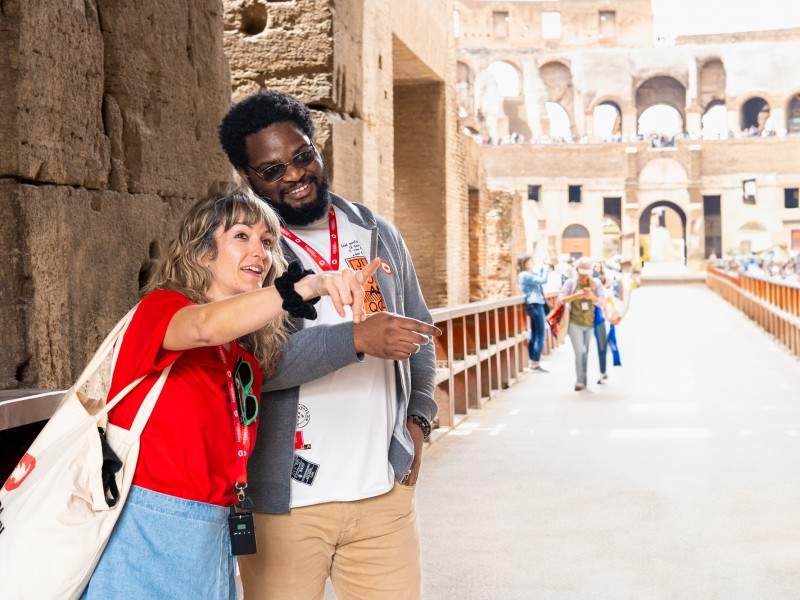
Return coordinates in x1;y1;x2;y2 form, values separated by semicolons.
706;267;800;356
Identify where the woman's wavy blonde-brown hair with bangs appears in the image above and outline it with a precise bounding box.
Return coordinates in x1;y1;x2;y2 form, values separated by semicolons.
142;188;287;373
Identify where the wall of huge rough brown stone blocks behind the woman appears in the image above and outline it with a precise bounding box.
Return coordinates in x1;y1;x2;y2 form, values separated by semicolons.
0;0;231;389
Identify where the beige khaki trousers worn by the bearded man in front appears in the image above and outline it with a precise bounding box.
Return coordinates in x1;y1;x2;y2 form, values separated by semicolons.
239;483;422;600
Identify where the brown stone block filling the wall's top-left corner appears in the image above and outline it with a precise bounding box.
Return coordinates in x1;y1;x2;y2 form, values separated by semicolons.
0;0;109;188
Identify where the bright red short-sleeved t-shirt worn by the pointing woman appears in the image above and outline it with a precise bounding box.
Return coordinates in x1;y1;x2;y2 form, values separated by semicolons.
108;290;262;506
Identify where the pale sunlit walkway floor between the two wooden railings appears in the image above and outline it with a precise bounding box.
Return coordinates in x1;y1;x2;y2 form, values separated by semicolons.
417;285;800;600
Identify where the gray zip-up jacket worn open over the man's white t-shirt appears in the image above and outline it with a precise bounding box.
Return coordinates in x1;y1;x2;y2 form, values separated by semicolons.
248;194;437;513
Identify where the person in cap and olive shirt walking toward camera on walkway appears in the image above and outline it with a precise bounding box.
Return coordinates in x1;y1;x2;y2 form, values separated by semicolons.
558;257;603;392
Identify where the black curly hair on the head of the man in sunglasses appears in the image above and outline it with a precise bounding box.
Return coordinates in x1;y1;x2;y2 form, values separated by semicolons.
219;90;314;169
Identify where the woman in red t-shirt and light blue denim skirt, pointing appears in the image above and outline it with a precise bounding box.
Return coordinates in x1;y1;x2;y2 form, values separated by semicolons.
83;191;379;599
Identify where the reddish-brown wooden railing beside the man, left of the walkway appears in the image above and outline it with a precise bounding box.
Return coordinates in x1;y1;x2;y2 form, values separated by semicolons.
431;296;556;428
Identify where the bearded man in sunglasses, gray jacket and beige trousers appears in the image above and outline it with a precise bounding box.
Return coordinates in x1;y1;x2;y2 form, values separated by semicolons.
220;91;440;600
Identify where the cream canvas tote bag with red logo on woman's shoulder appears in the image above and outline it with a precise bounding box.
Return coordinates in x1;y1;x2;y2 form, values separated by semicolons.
0;307;170;600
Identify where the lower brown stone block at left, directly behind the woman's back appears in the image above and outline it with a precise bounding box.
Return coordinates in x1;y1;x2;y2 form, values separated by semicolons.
0;180;192;388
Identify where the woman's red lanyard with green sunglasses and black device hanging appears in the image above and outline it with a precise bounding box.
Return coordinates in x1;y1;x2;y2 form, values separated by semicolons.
218;346;258;556
